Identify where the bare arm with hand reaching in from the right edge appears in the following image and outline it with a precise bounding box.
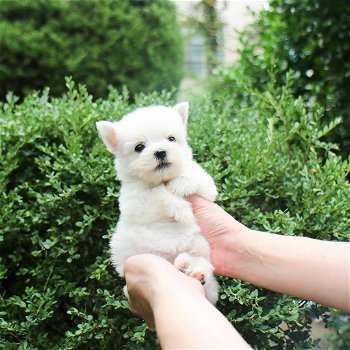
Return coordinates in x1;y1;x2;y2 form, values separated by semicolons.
189;196;350;312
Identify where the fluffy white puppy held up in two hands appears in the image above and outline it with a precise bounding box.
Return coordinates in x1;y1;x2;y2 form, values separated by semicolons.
96;102;218;304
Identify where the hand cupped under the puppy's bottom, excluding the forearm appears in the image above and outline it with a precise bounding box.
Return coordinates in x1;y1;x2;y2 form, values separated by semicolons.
124;254;204;328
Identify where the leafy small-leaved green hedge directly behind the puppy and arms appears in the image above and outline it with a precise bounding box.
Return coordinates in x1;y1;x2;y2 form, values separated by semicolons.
0;80;350;349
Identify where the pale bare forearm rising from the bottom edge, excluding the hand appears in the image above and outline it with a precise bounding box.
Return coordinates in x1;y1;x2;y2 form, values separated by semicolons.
153;292;250;349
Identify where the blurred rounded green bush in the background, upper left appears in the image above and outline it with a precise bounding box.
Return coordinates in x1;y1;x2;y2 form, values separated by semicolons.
0;0;183;99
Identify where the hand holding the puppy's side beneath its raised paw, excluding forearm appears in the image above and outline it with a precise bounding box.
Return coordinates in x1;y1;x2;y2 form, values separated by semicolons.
187;195;251;277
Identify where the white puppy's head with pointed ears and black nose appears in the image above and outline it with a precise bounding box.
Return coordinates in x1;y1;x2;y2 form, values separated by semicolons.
96;102;192;185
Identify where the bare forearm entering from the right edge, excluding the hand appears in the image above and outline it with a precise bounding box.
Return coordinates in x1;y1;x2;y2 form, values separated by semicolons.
232;231;350;311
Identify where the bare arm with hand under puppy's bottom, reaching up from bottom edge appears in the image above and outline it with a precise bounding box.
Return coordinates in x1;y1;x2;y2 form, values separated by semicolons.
124;254;250;349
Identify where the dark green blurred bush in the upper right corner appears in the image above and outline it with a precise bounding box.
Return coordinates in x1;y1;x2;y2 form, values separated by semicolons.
215;0;350;156
